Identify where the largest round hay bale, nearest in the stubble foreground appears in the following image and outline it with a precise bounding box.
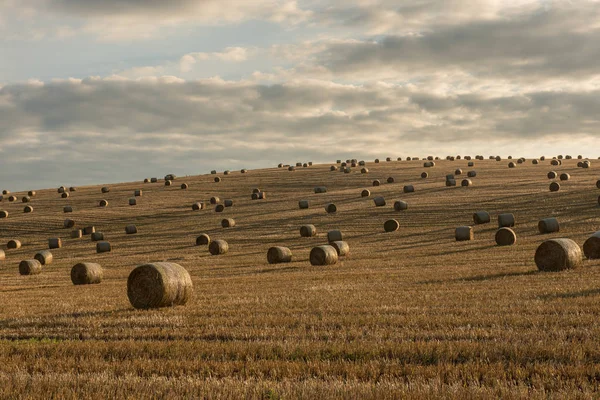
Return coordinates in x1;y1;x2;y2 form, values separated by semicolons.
127;262;194;309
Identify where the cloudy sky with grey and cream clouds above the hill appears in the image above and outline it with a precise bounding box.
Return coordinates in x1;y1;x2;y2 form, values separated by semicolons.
0;0;600;191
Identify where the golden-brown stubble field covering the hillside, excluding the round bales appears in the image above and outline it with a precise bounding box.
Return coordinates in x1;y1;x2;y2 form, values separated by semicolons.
0;159;600;399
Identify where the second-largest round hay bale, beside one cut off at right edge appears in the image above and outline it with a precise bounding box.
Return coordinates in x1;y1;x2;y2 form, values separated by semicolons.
534;238;583;271
